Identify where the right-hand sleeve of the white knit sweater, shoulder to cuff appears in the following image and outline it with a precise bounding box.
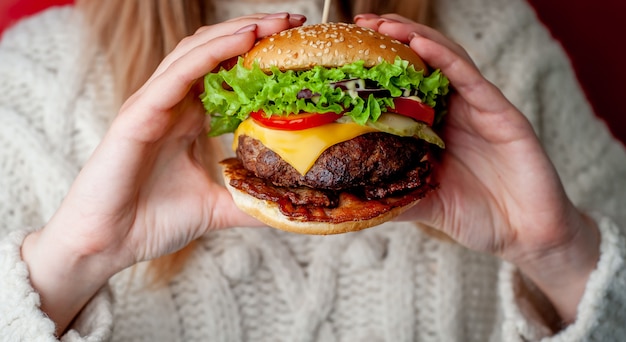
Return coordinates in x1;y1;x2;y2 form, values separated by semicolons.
482;0;626;341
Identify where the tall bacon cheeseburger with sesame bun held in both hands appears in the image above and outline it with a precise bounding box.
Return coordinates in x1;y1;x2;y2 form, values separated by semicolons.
201;23;449;234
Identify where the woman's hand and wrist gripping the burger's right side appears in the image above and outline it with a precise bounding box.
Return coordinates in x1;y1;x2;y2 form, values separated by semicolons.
355;15;599;322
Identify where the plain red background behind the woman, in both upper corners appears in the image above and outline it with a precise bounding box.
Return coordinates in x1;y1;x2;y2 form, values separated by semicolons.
0;0;626;142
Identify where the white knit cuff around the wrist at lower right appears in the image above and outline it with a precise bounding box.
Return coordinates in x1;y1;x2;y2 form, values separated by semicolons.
500;215;626;342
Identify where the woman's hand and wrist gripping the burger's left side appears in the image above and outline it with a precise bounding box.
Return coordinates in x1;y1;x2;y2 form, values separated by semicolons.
22;13;304;332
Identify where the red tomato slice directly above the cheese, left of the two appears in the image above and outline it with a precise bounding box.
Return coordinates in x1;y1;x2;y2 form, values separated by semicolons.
250;110;343;131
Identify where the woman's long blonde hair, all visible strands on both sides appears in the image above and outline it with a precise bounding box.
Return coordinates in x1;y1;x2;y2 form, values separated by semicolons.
76;0;429;285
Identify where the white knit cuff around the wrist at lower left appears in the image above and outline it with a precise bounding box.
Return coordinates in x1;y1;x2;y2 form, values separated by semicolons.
0;230;113;342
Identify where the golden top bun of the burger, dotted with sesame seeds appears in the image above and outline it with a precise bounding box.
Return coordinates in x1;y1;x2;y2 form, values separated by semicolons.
244;23;426;71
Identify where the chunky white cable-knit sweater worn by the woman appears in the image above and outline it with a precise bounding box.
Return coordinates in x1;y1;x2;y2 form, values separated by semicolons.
0;0;626;342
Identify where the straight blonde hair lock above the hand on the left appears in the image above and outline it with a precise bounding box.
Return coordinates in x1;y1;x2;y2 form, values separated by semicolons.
76;0;212;104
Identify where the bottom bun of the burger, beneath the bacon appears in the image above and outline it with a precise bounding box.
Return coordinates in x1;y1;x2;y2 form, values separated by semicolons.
222;159;434;235
